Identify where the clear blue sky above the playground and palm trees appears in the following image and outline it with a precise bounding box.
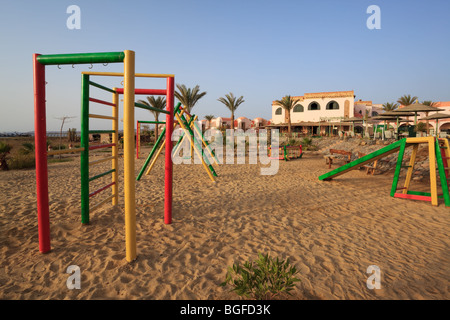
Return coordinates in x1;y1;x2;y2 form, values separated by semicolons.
0;0;450;132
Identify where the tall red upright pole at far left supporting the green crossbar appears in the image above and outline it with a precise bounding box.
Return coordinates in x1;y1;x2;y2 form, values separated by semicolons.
33;53;50;253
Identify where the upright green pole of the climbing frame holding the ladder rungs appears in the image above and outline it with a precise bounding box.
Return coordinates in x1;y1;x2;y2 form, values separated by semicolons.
80;74;89;224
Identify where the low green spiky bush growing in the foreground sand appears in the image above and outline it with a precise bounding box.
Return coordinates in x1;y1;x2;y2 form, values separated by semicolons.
220;253;300;300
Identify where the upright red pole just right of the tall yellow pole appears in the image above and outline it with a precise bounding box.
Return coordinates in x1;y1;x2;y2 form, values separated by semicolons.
164;77;175;224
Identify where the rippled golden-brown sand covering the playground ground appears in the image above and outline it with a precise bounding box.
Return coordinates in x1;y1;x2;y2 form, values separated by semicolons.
0;153;450;300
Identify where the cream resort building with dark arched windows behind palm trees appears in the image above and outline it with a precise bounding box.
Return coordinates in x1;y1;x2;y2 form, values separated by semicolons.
267;90;355;135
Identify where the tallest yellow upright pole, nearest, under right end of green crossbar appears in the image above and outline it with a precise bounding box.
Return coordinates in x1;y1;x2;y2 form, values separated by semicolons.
123;50;136;262
